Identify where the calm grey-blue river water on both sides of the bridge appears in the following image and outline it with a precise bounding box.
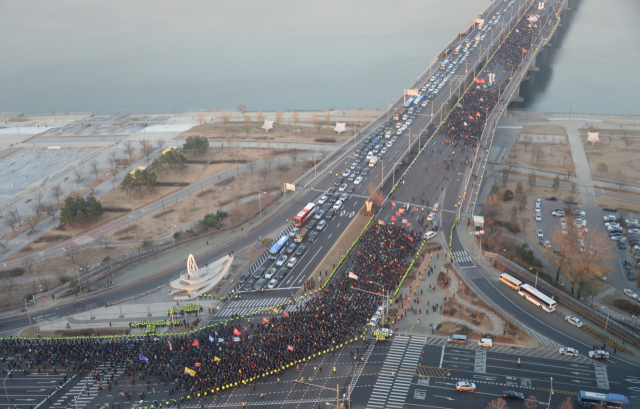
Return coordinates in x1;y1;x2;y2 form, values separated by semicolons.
0;0;640;113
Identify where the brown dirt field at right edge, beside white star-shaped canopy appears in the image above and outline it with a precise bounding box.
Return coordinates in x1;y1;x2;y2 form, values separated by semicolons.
580;133;640;186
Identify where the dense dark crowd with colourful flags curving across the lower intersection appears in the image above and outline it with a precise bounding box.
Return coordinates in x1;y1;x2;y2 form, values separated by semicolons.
1;225;419;397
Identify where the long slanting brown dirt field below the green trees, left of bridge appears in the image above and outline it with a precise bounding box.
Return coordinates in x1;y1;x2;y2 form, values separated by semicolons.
108;162;309;241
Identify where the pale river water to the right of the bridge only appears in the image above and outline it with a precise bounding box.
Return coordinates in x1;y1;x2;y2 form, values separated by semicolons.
516;0;640;115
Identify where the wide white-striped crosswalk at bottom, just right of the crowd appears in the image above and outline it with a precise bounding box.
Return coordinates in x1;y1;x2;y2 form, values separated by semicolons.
367;337;425;409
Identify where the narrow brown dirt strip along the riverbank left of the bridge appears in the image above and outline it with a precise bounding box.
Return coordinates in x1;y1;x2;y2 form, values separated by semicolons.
175;115;374;146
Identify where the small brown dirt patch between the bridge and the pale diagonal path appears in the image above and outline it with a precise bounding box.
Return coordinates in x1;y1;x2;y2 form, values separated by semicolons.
505;139;573;175
